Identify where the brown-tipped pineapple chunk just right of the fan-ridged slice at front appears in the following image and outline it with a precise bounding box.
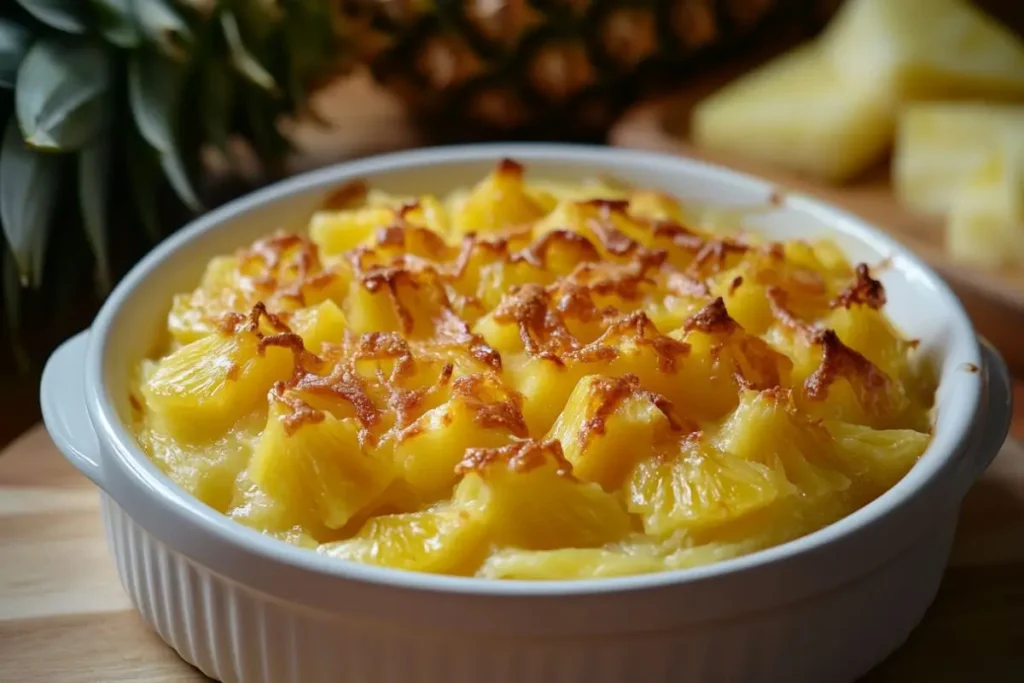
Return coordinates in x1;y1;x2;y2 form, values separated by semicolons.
713;390;850;508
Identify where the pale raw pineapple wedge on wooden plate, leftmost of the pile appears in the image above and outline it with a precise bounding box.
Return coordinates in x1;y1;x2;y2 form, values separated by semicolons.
691;45;893;182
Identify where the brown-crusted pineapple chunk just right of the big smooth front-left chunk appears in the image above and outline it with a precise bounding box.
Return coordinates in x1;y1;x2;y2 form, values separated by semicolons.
394;375;527;501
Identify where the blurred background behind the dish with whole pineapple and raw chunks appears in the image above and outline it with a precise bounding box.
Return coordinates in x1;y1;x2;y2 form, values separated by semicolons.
0;0;1024;445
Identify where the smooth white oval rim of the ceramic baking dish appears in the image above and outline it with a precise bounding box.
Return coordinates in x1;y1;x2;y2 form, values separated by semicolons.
84;143;983;597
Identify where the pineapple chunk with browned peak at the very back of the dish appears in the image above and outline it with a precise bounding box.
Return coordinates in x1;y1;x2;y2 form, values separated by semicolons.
452;161;545;236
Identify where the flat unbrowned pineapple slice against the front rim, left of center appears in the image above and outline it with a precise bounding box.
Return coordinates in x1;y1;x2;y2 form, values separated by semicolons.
318;505;486;575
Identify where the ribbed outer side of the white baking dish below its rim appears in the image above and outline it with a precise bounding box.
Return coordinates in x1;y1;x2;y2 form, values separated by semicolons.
102;495;955;683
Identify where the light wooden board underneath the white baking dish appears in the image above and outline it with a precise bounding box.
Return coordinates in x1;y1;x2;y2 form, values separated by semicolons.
0;405;1024;683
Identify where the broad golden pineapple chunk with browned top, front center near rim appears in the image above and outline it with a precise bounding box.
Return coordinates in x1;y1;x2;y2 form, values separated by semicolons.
455;440;630;550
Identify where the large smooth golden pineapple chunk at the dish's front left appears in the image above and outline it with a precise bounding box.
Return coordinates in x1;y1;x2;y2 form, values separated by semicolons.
249;401;395;528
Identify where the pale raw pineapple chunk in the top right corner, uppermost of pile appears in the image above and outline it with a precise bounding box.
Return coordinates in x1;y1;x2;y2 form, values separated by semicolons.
821;0;1024;103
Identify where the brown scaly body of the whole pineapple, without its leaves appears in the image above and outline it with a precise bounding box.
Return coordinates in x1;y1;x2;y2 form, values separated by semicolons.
339;0;840;137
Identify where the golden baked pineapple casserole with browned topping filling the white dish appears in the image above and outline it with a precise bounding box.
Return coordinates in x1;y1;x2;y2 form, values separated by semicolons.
131;161;935;580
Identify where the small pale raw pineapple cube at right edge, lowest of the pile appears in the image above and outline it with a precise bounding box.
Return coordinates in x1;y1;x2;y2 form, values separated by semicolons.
946;150;1024;268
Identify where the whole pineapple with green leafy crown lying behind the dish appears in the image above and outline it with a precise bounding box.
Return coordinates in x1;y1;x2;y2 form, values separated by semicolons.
0;0;836;372
